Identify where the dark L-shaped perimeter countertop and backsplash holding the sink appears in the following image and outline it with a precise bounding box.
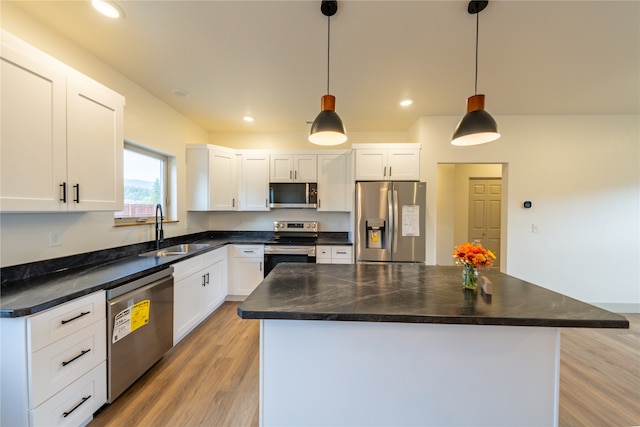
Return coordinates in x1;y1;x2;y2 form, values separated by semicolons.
0;232;351;317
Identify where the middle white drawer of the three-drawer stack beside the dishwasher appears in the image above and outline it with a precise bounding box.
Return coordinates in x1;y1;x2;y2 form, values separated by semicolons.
30;317;107;408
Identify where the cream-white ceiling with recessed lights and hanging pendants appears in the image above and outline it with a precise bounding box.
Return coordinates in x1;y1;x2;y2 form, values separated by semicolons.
7;0;640;132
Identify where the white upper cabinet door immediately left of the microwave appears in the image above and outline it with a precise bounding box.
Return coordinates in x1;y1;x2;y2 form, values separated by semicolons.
238;151;269;211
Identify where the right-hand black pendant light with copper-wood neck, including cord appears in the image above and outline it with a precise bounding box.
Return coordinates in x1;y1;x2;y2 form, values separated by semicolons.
451;0;500;145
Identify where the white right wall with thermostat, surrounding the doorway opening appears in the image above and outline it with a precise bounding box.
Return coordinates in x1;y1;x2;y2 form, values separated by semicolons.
418;116;640;312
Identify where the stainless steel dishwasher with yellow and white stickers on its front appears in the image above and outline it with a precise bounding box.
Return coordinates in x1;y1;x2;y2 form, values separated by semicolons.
107;267;173;403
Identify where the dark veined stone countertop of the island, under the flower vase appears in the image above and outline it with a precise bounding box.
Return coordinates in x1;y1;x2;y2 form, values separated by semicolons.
238;263;629;328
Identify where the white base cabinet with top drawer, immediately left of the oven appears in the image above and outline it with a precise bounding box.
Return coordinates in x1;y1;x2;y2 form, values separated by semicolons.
229;245;264;296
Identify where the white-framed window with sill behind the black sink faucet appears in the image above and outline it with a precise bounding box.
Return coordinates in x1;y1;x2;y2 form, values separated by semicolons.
114;141;169;225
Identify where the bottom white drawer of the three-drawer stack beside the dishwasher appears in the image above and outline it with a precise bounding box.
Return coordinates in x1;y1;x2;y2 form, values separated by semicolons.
30;361;107;426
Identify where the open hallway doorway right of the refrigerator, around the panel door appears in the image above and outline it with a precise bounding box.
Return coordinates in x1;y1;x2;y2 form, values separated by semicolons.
435;163;508;269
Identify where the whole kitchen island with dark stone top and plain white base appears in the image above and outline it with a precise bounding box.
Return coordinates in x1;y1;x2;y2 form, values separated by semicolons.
238;264;629;426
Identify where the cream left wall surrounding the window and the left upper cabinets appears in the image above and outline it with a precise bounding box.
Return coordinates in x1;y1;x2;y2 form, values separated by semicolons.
0;2;209;267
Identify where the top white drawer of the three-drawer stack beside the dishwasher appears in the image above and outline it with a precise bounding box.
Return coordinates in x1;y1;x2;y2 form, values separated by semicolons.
28;291;106;352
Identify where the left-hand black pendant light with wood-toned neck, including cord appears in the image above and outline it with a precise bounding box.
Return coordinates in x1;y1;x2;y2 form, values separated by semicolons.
309;0;347;145
